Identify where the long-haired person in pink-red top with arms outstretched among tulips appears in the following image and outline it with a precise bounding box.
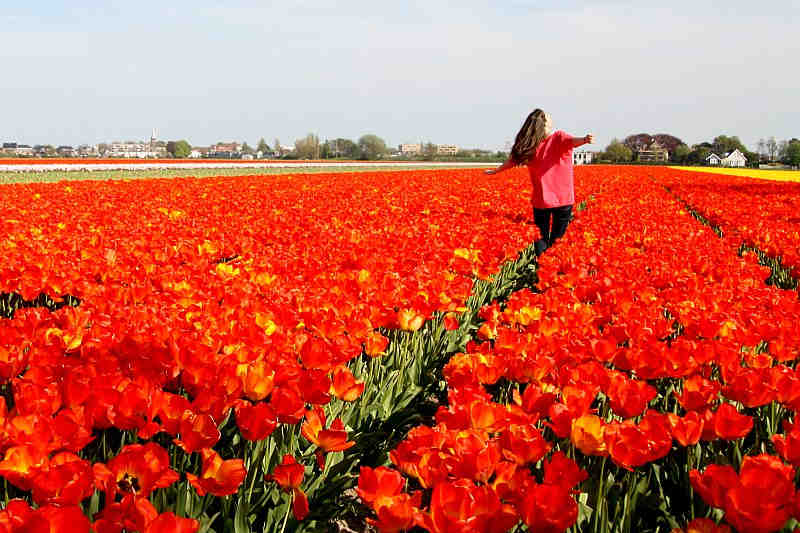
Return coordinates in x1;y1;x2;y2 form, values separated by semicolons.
486;109;594;255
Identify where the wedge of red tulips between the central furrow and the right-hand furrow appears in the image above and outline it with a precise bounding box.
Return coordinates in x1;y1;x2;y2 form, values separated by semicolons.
358;168;800;532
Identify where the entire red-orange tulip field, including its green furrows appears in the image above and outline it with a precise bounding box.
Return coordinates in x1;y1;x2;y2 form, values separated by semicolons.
0;166;800;533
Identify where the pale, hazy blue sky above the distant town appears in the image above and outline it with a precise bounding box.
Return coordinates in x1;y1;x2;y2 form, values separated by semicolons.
0;0;800;148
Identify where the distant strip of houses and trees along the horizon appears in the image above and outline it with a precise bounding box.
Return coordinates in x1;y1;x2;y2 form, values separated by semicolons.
0;130;800;168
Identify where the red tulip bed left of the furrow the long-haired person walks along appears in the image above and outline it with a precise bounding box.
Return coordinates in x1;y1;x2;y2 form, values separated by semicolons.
0;171;588;533
